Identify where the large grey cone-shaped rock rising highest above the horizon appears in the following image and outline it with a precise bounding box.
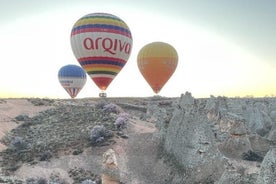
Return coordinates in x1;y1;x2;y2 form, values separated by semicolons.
164;93;224;183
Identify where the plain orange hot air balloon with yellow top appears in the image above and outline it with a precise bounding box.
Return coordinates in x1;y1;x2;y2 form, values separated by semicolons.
137;42;178;94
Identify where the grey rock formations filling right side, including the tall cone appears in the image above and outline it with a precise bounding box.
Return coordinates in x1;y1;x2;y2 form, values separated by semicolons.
162;92;276;184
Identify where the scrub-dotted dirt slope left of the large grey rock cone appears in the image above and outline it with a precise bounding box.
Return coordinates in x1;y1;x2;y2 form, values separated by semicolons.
0;98;177;183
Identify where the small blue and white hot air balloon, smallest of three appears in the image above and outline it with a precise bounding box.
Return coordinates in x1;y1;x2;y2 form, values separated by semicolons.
58;65;86;98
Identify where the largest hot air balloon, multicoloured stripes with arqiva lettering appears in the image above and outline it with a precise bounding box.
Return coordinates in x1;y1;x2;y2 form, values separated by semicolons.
71;13;132;95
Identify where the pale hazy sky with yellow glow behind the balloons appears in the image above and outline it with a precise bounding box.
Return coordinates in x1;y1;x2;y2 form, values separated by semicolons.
0;0;276;98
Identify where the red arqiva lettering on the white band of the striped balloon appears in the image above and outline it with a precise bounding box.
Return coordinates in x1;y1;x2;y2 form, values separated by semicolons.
83;37;131;55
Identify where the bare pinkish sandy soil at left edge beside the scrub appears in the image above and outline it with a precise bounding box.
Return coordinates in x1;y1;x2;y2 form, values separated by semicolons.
0;99;51;151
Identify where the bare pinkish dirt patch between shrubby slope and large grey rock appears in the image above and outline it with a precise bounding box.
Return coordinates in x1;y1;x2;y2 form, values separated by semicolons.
110;118;171;184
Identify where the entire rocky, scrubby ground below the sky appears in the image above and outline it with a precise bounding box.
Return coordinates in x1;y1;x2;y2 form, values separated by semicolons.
0;93;276;184
